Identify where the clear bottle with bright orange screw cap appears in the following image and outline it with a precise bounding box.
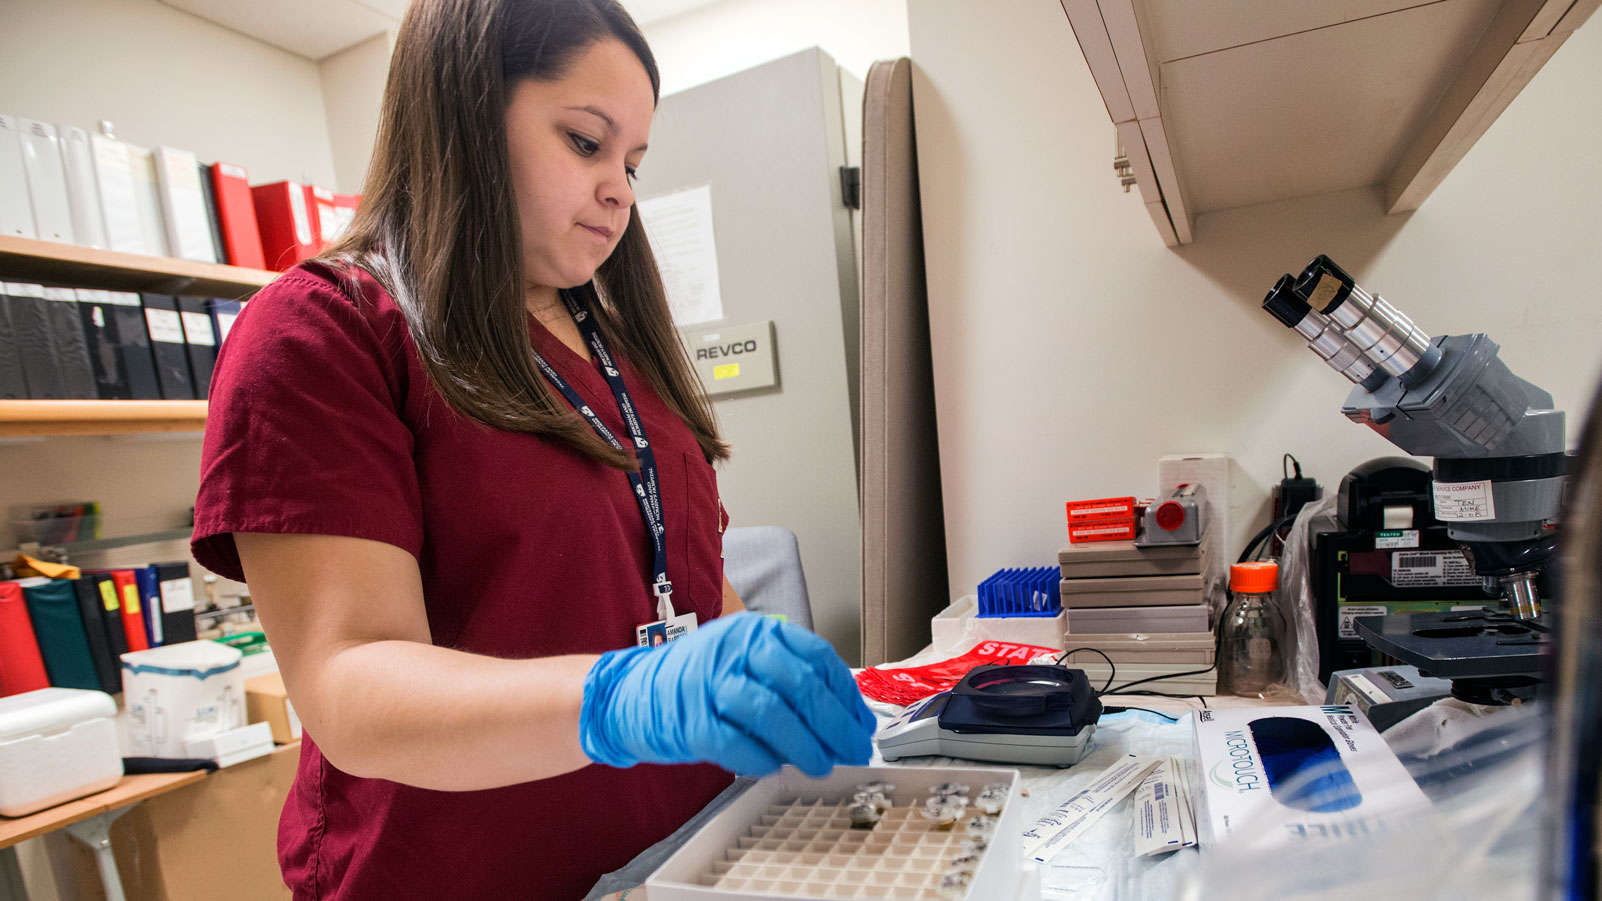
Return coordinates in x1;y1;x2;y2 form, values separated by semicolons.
1218;561;1285;696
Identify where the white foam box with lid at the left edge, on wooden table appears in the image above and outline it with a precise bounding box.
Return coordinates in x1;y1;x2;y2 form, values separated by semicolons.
0;688;122;816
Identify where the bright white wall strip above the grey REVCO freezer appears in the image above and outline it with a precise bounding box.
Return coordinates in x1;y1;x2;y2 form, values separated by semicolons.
641;0;908;95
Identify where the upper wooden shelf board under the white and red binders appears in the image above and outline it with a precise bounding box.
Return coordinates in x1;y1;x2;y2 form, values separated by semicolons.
0;236;279;300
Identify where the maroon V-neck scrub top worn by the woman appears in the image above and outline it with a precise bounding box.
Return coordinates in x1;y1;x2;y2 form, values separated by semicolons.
194;263;731;899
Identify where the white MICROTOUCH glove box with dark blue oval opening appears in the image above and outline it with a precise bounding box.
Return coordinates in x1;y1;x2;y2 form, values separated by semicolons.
1190;705;1431;846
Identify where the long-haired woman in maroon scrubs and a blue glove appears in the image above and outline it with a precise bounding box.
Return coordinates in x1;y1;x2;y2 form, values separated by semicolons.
194;0;873;899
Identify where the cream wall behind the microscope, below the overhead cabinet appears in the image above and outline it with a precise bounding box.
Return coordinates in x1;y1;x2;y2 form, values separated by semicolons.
908;0;1602;593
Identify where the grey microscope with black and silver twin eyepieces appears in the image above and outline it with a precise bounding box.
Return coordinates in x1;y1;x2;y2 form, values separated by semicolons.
1262;255;1568;704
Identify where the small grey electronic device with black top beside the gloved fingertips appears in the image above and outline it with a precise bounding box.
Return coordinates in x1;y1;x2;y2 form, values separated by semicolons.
873;664;1102;766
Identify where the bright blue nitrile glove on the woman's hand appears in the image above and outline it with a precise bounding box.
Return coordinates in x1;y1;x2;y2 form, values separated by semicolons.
578;612;875;776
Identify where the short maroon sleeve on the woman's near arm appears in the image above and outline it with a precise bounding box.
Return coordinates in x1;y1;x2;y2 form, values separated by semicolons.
191;269;423;580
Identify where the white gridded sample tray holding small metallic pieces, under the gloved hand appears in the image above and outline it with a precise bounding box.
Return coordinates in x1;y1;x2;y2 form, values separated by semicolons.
646;766;1038;901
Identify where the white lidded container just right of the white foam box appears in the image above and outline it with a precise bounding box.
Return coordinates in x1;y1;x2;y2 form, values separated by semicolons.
122;641;245;758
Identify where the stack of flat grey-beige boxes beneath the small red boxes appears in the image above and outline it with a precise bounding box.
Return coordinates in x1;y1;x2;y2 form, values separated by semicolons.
1057;531;1218;694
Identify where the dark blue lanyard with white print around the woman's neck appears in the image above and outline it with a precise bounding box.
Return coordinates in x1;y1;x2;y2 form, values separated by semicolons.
533;292;673;619
